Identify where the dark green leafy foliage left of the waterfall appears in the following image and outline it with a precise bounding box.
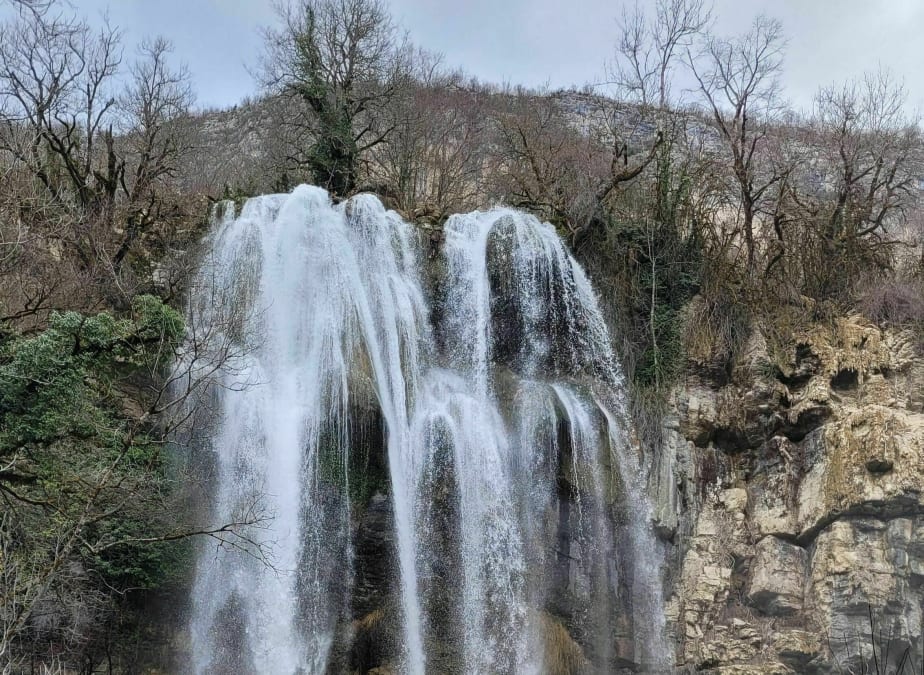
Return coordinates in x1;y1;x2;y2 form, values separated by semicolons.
0;295;184;604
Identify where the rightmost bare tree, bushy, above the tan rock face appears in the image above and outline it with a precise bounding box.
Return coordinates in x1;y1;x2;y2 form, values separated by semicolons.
782;71;924;300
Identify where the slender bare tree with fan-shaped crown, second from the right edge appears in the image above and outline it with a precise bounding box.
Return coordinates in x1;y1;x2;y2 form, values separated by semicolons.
689;16;784;270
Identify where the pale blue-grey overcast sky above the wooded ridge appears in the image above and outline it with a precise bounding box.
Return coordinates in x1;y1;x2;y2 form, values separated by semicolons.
12;0;924;115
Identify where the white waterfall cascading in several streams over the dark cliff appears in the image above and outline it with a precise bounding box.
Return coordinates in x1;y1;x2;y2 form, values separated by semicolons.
184;186;668;674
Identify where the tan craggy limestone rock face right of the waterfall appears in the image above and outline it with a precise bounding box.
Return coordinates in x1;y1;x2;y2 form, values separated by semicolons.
652;316;924;674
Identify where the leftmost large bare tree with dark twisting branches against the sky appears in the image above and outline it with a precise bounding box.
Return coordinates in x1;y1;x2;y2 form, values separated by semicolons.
0;12;121;320
